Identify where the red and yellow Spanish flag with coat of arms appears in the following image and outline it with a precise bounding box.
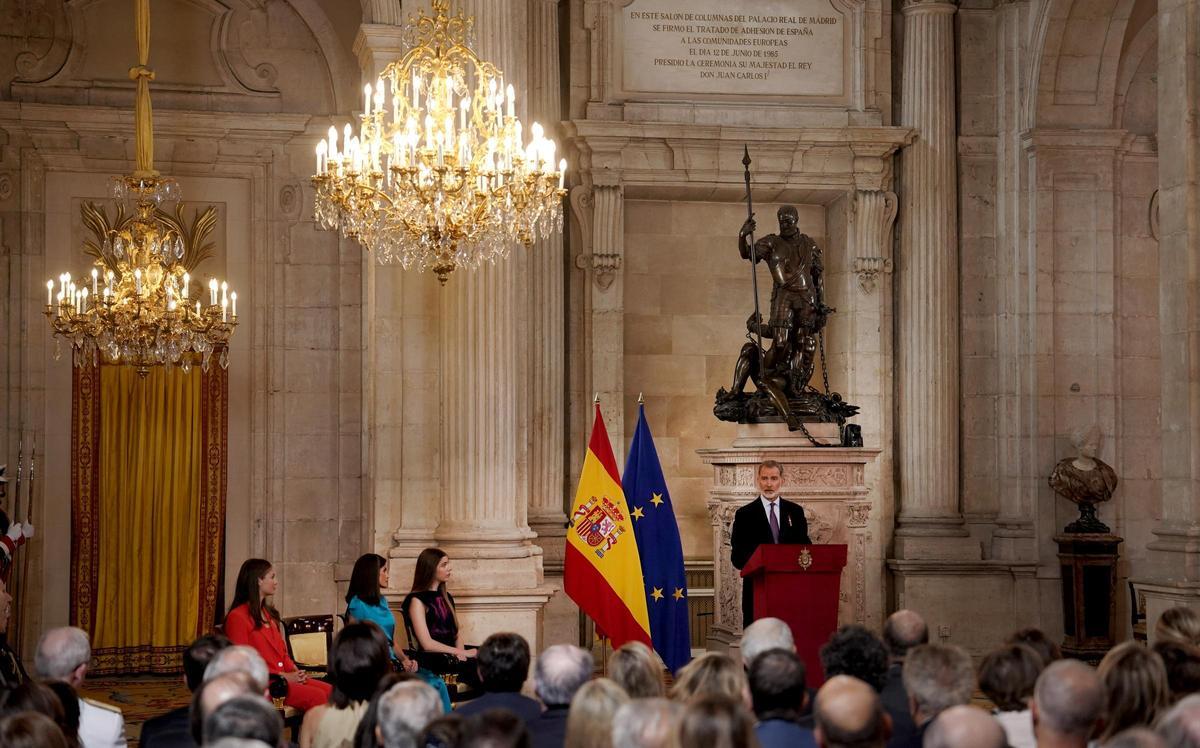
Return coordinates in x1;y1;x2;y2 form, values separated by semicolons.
563;405;650;647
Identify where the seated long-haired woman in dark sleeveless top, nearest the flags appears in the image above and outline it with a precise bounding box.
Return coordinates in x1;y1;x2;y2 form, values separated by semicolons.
400;547;479;688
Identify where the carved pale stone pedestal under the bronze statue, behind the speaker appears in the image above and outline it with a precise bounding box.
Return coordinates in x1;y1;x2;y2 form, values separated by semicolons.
697;425;883;651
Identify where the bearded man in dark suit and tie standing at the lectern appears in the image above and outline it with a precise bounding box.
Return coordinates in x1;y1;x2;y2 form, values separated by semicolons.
730;460;812;626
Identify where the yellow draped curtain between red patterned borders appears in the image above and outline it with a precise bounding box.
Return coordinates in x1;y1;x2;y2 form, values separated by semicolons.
91;366;206;670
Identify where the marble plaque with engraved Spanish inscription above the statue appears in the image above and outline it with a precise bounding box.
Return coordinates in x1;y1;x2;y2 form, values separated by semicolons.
620;0;847;97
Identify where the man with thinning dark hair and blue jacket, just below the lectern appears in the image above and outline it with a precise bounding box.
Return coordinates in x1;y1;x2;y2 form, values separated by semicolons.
746;650;816;748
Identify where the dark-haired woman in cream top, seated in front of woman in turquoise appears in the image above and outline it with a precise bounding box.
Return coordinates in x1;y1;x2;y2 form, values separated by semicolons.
300;622;391;748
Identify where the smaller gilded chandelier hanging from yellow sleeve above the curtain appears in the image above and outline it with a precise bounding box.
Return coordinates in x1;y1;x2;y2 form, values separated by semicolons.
46;0;238;376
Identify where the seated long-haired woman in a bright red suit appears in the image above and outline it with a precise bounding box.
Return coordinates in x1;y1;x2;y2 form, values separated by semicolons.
224;558;332;710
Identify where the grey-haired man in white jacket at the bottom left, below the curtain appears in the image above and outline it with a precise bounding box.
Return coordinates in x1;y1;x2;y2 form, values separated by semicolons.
34;626;126;748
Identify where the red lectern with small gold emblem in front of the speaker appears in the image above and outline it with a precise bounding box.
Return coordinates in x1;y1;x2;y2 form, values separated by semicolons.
742;543;846;687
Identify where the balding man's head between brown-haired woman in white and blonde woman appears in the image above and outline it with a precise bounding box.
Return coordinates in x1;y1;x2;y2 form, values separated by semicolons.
1031;659;1106;748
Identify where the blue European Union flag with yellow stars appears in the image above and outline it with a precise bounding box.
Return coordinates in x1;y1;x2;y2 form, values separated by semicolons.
622;406;691;672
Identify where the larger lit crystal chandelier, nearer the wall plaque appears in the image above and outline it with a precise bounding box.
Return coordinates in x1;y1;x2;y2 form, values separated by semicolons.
312;0;566;285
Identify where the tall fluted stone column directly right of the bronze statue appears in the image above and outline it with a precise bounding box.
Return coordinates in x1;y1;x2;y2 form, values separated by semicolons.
895;0;979;558
